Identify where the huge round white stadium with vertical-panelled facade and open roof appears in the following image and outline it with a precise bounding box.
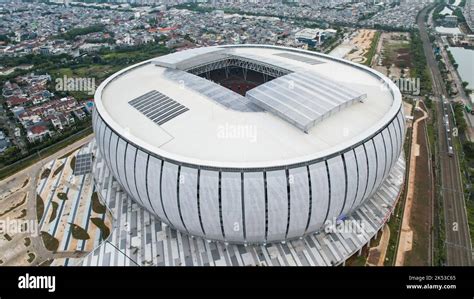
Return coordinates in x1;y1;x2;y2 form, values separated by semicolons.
93;45;405;244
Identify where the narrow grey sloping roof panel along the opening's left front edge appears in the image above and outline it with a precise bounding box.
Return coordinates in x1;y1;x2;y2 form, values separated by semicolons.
164;70;262;112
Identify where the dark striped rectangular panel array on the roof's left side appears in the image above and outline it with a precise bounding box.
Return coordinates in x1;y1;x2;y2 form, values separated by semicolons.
128;90;189;126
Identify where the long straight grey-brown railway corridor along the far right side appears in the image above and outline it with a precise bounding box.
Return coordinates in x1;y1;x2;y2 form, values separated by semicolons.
417;7;472;266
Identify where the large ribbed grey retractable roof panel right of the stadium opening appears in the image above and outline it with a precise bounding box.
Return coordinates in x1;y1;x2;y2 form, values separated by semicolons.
246;71;366;132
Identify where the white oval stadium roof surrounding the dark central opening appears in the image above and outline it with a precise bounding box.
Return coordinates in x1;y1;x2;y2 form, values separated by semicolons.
95;45;401;167
